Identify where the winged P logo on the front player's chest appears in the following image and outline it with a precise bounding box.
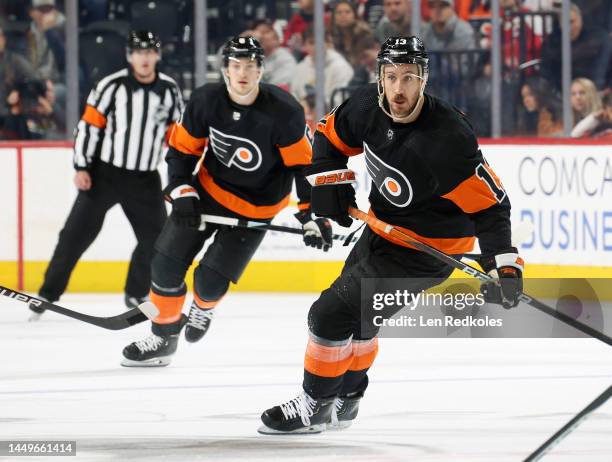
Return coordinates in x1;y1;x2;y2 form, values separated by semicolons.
363;143;412;207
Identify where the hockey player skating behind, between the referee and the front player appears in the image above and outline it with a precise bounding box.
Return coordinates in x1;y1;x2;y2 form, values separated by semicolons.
122;37;332;366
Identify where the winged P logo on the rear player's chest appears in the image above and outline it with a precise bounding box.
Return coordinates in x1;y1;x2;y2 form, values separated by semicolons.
210;127;262;172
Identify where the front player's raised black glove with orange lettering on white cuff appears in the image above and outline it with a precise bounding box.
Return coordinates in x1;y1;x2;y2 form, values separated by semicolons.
307;168;357;228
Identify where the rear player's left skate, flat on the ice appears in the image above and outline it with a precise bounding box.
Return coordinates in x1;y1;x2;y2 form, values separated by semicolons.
121;334;178;367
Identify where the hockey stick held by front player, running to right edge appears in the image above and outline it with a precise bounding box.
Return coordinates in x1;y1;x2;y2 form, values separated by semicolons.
349;207;612;346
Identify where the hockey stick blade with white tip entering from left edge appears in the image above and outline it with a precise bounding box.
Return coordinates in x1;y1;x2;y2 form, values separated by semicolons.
0;286;159;330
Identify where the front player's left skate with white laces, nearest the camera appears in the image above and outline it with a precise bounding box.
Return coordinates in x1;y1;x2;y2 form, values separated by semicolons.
257;392;334;435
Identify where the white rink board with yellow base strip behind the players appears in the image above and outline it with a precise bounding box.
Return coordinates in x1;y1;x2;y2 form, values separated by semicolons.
0;140;612;292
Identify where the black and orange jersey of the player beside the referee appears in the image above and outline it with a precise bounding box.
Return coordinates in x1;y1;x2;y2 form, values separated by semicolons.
166;83;312;220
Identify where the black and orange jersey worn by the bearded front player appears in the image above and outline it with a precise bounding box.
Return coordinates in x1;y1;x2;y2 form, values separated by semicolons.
312;84;511;255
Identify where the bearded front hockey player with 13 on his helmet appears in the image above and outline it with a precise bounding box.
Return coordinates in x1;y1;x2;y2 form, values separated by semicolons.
259;37;523;434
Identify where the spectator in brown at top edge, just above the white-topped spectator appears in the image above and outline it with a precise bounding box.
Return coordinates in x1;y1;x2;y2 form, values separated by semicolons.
331;0;371;67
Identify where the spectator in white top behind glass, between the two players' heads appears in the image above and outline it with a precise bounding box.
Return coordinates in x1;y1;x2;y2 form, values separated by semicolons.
290;27;353;109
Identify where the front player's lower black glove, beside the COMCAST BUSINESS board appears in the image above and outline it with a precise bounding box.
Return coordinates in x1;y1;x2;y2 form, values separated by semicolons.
479;247;524;309
